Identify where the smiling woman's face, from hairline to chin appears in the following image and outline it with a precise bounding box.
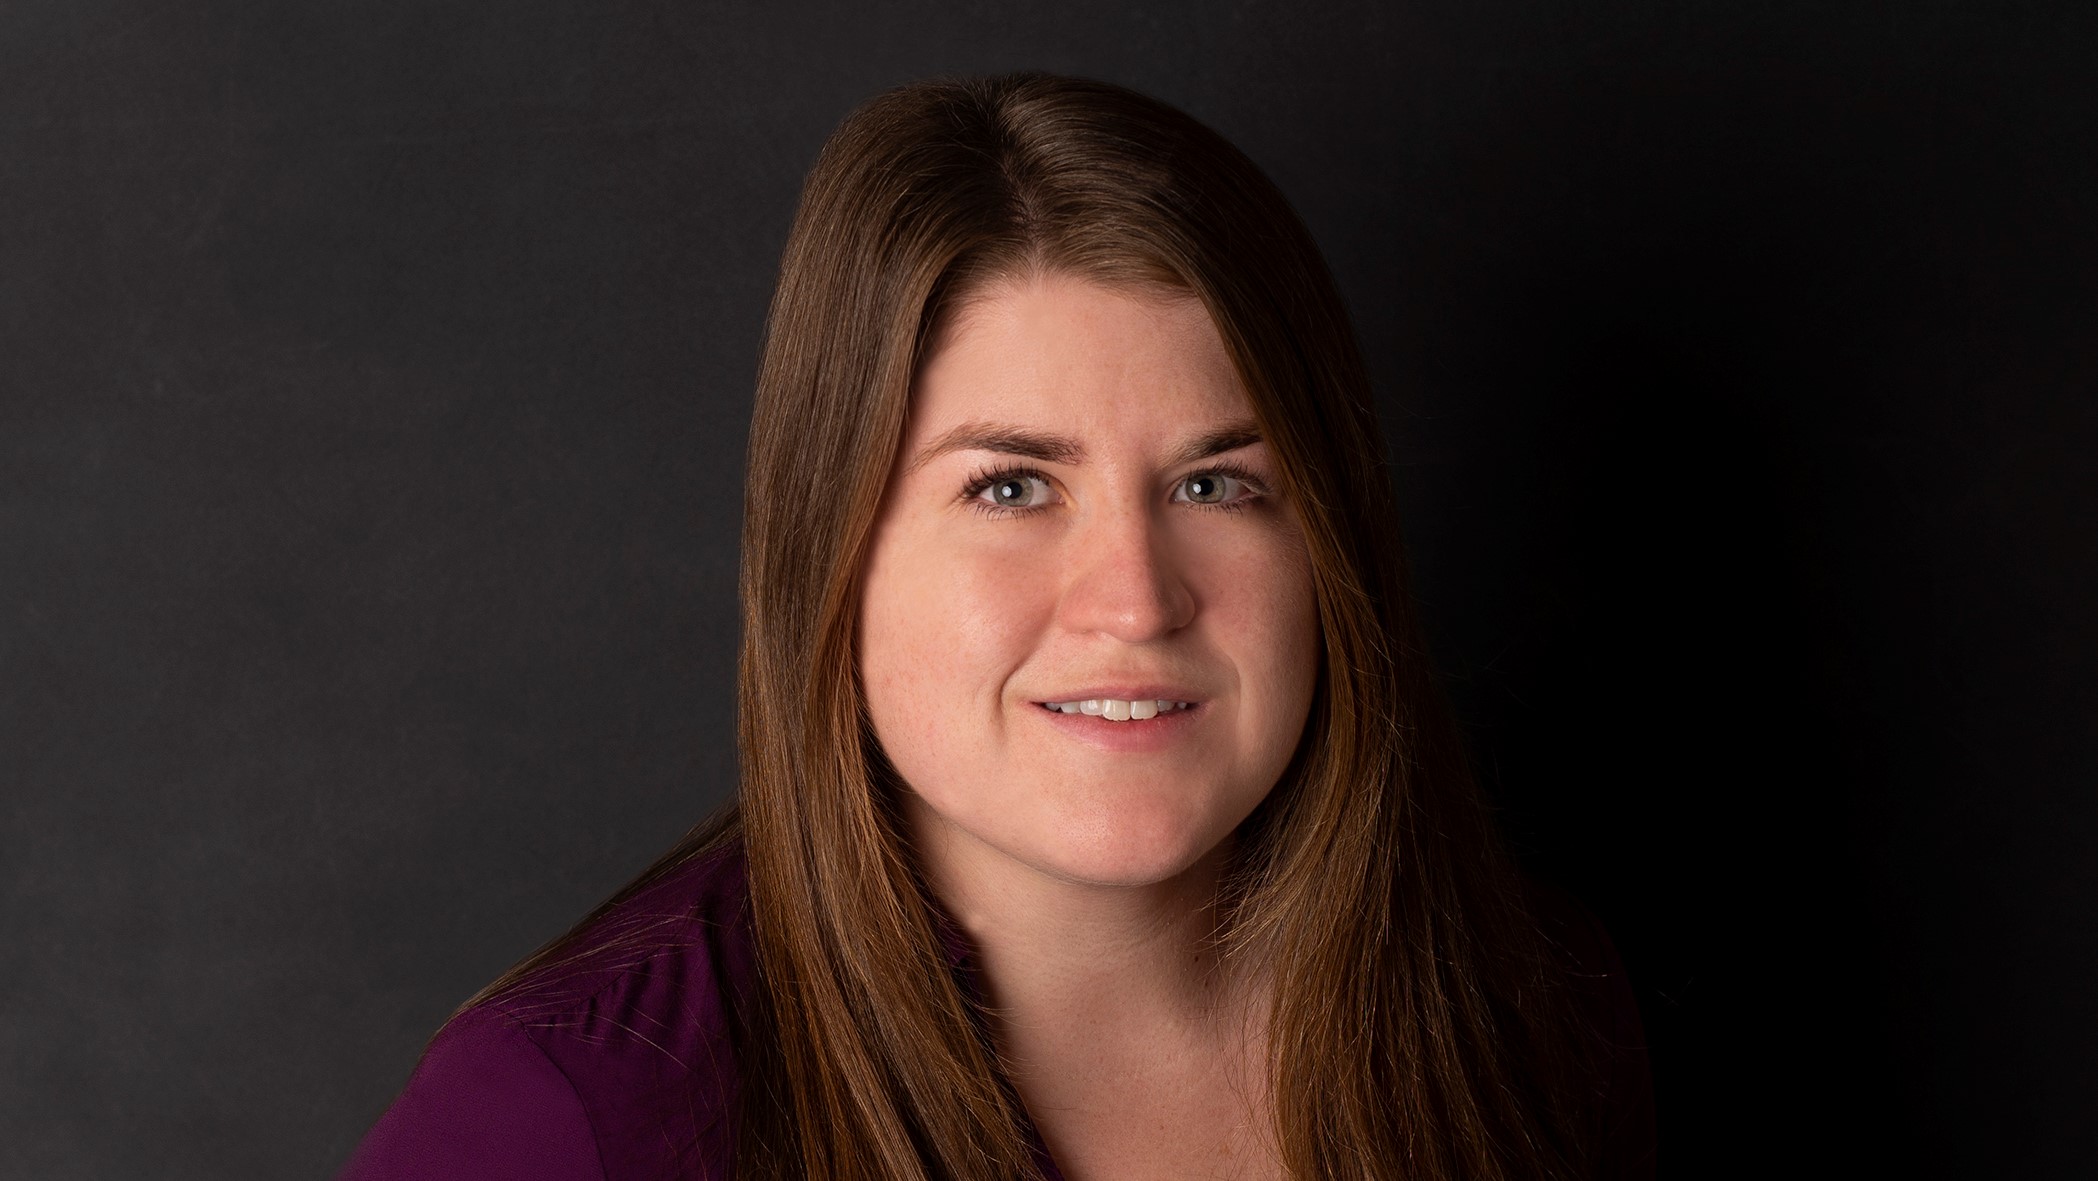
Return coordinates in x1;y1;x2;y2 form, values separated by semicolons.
858;275;1320;885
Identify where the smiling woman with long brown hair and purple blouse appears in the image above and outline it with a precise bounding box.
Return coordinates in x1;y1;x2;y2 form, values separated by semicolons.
348;76;1649;1179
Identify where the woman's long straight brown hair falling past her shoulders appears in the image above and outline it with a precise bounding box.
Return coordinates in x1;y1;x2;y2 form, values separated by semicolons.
480;73;1584;1181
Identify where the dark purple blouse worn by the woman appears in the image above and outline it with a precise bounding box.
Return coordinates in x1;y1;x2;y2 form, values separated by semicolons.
338;847;1653;1181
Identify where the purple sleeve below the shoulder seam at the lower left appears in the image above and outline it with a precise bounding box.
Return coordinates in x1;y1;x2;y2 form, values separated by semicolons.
338;1009;604;1181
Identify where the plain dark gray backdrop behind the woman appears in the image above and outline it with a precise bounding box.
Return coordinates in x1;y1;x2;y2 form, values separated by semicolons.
0;0;2098;1179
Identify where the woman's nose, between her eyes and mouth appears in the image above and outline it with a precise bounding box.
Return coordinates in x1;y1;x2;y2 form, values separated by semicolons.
1059;506;1196;644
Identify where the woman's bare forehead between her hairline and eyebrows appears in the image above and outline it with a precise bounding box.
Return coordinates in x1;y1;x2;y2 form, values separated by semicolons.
908;273;1253;447
